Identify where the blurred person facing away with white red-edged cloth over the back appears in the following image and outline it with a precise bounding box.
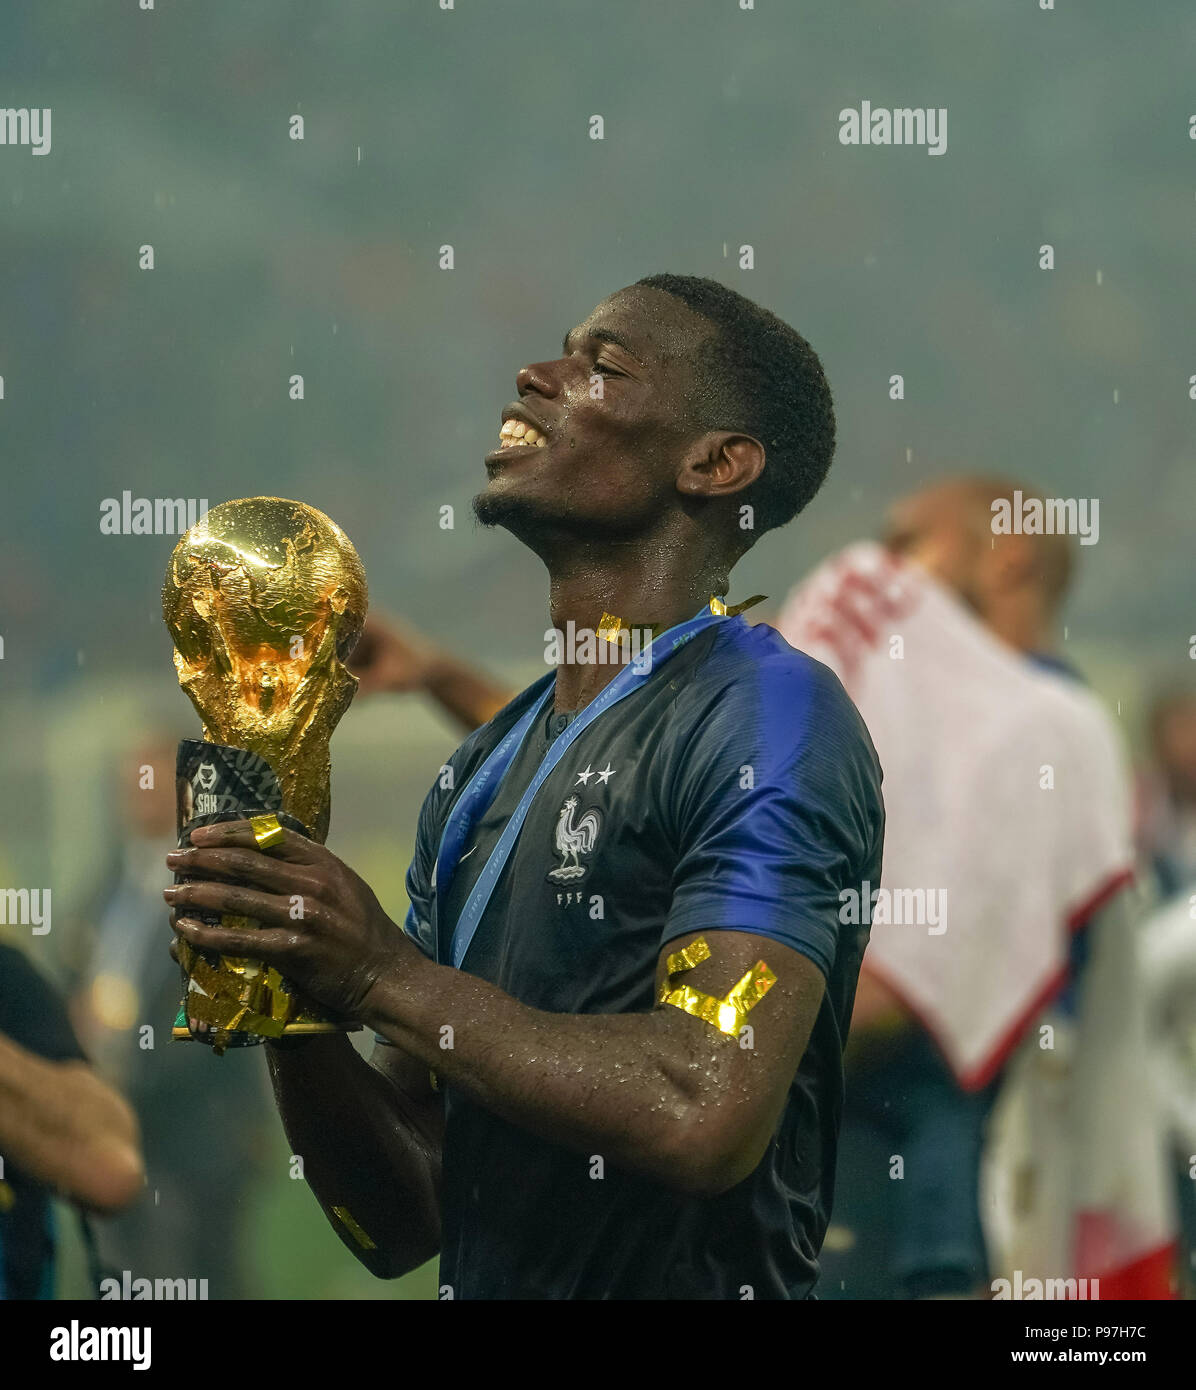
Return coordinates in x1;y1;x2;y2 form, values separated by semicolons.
776;478;1174;1298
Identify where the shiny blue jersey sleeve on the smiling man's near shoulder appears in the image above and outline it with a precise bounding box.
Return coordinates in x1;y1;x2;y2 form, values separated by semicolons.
661;649;884;977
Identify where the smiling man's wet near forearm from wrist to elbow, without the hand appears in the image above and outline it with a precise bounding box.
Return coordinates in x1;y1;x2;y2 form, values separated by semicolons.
364;962;750;1191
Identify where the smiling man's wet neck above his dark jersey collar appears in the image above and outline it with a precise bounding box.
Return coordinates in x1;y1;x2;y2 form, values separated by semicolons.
549;546;727;712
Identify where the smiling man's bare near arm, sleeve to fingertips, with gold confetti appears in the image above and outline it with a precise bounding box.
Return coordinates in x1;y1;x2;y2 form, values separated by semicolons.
164;821;826;1201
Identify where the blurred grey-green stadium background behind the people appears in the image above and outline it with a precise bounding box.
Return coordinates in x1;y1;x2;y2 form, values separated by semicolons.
0;0;1196;1298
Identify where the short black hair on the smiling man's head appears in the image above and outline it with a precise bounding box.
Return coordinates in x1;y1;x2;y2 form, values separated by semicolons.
636;274;834;539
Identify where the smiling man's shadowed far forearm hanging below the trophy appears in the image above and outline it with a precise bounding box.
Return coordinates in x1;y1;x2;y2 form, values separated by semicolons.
267;1034;439;1279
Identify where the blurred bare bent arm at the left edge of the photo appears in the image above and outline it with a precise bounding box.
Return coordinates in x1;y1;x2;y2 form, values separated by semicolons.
0;1034;145;1212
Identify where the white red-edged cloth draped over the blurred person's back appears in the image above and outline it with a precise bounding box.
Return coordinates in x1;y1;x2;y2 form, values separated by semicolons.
776;543;1132;1090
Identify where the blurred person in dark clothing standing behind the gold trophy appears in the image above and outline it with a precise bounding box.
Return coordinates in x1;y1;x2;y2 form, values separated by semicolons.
74;737;270;1298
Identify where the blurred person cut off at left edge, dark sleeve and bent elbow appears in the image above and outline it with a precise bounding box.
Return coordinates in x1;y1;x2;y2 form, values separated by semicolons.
0;945;145;1298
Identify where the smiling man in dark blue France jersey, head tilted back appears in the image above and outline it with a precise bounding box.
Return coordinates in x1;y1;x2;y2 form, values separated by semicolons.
167;275;883;1298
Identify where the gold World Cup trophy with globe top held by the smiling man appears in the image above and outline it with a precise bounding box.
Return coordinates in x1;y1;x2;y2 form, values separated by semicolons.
163;498;367;1052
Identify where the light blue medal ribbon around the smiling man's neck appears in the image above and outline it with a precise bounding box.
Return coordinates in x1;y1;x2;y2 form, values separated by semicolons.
435;606;726;967
